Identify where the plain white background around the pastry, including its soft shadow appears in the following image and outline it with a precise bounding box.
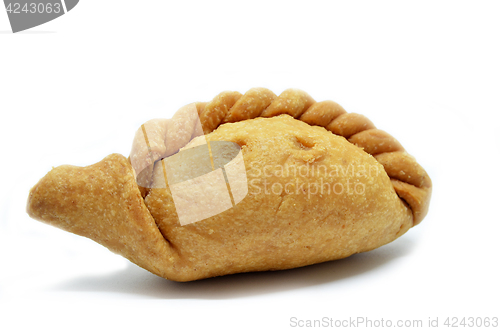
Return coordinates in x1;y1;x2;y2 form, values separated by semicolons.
0;0;500;330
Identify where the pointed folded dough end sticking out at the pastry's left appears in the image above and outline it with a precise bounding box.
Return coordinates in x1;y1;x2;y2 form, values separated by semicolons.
27;154;174;278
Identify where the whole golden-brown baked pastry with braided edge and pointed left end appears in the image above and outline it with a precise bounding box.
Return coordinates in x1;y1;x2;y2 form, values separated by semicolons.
27;88;432;281
